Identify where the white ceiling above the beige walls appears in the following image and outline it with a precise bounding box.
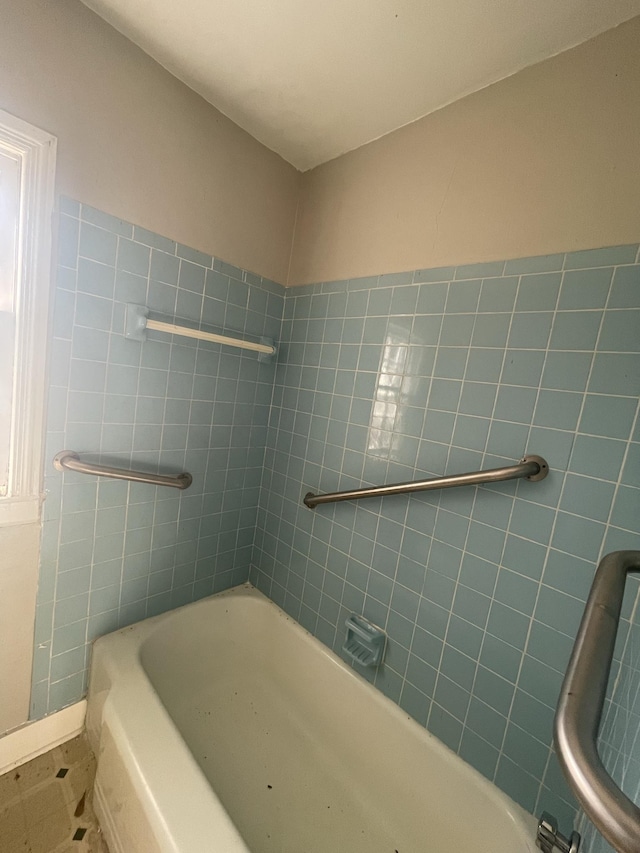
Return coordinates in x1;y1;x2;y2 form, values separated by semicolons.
84;0;640;170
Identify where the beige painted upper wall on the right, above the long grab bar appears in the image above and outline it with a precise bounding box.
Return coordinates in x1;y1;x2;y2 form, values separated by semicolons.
289;18;640;284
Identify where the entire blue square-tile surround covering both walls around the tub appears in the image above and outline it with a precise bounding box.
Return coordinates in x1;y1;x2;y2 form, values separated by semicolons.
32;206;640;840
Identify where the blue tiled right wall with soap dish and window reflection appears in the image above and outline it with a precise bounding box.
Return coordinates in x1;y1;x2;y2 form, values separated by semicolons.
250;245;640;831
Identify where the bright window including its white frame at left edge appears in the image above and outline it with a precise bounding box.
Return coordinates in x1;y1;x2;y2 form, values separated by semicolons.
0;111;56;524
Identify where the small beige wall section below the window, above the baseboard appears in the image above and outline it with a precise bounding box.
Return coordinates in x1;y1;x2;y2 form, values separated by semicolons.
0;524;40;734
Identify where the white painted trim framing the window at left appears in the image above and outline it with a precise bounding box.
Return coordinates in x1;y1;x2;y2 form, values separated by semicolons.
0;110;57;526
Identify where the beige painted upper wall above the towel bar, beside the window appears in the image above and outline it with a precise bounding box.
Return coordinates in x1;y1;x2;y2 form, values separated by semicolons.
0;0;300;282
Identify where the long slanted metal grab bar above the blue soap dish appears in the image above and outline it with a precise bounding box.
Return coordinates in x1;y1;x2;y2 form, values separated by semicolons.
303;456;549;509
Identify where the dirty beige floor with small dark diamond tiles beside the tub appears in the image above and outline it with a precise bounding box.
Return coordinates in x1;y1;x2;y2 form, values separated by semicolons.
0;735;109;853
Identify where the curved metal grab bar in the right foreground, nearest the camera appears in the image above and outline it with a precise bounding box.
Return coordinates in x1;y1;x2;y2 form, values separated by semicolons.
555;551;640;853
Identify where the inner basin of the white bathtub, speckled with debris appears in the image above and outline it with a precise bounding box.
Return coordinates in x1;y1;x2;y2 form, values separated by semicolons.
132;586;535;853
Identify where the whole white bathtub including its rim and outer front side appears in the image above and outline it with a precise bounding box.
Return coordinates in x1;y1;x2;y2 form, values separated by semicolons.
87;585;537;853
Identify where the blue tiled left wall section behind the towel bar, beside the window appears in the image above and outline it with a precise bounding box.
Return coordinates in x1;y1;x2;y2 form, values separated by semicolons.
31;199;284;718
